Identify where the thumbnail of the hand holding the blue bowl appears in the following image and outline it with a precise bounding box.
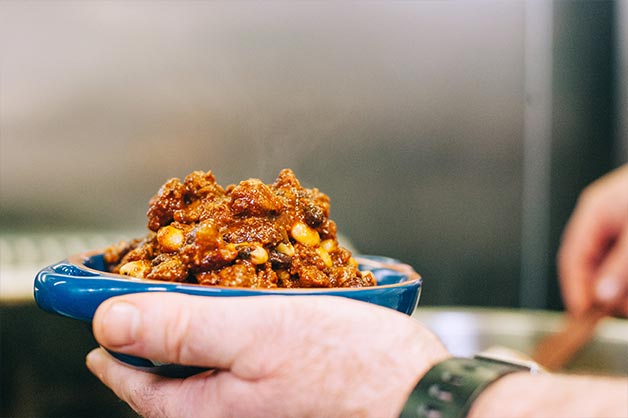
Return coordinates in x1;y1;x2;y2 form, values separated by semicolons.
100;302;141;347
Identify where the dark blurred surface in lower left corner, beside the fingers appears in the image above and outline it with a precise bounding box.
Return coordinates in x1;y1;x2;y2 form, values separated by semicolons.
0;302;137;418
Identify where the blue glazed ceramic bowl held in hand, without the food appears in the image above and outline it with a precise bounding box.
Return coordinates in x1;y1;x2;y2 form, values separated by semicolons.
34;251;422;377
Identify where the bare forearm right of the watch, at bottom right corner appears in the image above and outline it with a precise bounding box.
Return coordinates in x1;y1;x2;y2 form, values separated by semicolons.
468;373;628;418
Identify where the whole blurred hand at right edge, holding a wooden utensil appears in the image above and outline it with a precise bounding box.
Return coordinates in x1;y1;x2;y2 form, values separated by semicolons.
558;164;628;317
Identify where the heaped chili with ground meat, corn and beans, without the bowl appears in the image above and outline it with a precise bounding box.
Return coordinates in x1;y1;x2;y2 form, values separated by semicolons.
104;169;375;288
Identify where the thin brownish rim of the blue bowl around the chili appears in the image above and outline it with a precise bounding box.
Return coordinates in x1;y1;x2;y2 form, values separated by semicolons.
61;249;423;294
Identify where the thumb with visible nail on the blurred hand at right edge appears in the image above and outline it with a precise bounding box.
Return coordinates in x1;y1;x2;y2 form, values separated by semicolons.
594;226;628;316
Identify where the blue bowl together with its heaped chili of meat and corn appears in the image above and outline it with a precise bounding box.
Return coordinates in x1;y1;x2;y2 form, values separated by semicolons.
34;169;422;376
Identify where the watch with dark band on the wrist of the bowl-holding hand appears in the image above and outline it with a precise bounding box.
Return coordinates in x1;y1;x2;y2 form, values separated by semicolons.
400;350;542;418
